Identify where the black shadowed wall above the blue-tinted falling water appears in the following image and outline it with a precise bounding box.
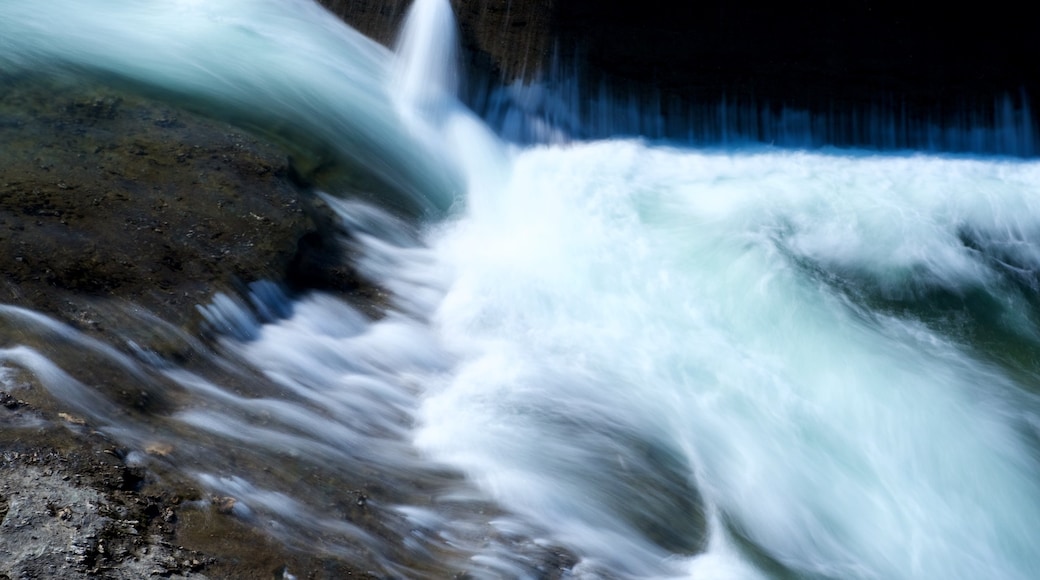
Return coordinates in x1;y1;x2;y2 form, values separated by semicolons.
320;0;1040;137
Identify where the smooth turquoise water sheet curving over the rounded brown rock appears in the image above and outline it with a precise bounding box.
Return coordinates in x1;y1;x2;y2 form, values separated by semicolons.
0;0;462;215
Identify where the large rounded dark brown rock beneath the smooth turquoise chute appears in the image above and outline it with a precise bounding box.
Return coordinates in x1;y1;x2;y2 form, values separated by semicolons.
0;77;372;347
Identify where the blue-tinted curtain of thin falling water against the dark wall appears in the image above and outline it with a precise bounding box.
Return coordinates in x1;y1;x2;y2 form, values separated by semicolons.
469;58;1040;158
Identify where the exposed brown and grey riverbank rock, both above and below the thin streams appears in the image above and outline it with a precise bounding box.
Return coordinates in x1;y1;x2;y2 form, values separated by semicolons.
0;77;379;578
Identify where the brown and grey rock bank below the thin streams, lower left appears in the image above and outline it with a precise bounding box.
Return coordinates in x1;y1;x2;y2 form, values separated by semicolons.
0;392;382;579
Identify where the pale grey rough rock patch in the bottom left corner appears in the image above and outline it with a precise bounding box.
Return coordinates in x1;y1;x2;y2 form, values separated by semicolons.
0;443;209;578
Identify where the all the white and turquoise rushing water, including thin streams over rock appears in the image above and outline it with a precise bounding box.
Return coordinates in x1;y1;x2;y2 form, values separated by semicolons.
0;0;1040;579
